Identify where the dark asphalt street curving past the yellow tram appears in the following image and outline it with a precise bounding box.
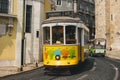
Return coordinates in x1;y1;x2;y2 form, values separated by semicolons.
0;57;120;80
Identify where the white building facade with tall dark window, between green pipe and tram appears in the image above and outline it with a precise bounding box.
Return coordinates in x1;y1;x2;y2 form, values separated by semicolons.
23;0;44;64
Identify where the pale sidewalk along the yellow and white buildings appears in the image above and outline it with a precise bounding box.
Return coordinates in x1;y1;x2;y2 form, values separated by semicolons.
0;62;43;77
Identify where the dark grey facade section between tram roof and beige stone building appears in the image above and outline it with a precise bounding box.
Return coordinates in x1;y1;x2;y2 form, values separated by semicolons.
78;0;95;39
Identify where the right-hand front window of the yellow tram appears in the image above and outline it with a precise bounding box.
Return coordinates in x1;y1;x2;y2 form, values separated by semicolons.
66;26;76;44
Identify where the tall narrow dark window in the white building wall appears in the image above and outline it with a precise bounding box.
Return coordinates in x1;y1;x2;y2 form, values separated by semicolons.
26;5;32;33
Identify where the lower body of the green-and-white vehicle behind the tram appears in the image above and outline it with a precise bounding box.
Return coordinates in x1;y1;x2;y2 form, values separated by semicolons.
89;45;106;57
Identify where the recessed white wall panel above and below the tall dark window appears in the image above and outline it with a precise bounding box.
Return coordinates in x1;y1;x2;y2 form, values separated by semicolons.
24;0;33;64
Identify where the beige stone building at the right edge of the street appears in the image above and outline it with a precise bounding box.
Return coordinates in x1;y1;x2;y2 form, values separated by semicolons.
95;0;120;59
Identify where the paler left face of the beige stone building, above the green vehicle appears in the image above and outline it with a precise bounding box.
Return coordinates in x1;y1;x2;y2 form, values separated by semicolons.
95;0;106;38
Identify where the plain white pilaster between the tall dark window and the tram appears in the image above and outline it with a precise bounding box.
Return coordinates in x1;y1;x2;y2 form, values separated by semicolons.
32;1;43;62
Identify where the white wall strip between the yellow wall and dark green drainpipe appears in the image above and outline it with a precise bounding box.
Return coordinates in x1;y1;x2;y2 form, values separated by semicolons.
16;0;23;67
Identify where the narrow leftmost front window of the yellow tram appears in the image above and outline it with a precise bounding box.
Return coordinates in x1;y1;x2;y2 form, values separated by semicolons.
43;27;50;44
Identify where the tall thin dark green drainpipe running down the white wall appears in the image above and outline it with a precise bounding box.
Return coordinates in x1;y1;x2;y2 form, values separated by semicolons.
20;0;25;71
